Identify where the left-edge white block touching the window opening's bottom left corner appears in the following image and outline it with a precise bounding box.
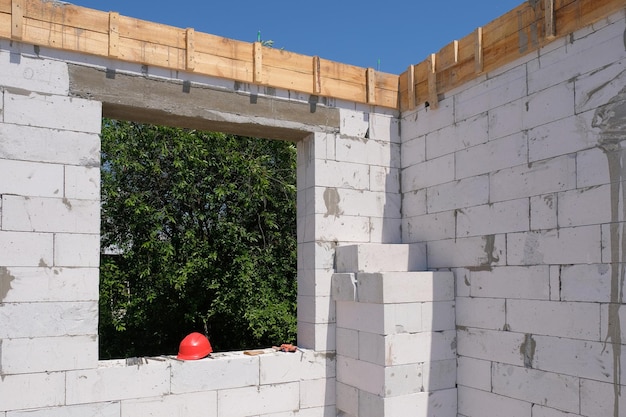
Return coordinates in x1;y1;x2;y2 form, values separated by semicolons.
0;334;98;375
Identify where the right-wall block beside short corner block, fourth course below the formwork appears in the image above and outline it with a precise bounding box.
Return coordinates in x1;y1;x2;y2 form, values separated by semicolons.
426;175;489;213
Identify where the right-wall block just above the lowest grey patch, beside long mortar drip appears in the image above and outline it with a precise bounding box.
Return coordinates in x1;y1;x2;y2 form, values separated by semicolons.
506;300;600;340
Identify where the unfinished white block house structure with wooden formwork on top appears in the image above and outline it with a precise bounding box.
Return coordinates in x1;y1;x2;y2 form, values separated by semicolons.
0;0;626;417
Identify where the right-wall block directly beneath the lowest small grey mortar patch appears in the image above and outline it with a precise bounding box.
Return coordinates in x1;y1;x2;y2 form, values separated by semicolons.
492;363;579;412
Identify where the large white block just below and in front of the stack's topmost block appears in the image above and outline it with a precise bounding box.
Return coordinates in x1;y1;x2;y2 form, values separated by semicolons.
357;272;454;304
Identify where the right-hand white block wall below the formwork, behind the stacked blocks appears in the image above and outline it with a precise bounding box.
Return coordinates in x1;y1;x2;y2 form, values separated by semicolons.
401;11;626;417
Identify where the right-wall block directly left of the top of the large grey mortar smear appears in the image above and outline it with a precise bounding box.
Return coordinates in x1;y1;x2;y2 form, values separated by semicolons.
528;112;598;162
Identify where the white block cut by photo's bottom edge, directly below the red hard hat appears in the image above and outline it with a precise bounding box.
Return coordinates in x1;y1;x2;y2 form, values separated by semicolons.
121;392;217;417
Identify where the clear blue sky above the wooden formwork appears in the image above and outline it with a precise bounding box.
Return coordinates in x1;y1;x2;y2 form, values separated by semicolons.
70;0;523;74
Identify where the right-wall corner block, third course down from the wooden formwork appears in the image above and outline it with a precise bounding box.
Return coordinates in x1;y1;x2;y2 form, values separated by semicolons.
401;154;454;192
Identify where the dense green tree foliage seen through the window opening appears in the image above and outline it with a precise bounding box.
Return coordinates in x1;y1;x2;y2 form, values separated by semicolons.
99;119;297;358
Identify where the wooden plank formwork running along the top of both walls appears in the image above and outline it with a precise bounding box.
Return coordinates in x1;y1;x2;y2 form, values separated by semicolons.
0;0;626;110
